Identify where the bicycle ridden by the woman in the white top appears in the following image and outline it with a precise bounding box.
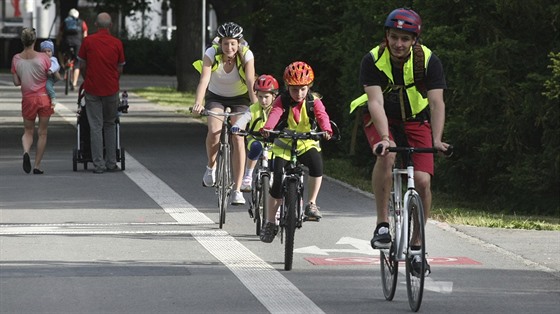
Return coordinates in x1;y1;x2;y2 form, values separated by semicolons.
197;107;243;229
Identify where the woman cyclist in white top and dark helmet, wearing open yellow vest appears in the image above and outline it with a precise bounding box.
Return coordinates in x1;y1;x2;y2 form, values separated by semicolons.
193;22;258;205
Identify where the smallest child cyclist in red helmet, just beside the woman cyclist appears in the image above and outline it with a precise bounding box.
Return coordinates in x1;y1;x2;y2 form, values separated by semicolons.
231;74;279;192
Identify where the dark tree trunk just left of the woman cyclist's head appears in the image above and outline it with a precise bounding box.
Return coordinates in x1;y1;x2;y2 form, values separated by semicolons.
173;0;202;92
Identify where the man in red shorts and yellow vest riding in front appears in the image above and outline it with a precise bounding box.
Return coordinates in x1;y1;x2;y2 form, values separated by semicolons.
358;8;449;272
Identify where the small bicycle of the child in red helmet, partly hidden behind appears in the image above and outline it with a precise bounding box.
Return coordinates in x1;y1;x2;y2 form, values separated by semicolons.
236;118;272;235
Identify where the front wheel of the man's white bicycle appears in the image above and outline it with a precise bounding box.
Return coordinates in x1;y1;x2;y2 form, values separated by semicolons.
406;194;426;312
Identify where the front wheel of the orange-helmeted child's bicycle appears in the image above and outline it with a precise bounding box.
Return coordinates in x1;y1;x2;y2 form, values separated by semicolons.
284;180;298;270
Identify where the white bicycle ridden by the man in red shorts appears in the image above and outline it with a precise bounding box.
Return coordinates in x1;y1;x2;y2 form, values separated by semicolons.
376;145;453;312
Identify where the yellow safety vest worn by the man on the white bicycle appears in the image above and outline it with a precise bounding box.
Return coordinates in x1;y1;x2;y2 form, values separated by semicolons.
350;45;432;121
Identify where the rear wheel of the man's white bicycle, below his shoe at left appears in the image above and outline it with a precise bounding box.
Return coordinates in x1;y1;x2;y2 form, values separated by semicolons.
379;205;399;301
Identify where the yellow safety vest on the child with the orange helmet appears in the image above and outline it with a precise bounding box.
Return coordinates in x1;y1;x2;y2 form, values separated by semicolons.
272;100;321;160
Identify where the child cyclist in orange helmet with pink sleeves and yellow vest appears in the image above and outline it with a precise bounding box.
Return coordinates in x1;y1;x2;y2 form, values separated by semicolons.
260;61;333;243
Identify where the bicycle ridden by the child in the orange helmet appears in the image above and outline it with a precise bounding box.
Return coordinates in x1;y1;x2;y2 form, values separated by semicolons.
266;121;340;270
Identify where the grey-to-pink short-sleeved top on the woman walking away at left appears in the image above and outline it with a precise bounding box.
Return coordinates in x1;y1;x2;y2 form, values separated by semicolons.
11;53;51;97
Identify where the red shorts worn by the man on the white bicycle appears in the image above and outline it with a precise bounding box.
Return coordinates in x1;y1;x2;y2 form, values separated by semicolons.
363;112;434;176
